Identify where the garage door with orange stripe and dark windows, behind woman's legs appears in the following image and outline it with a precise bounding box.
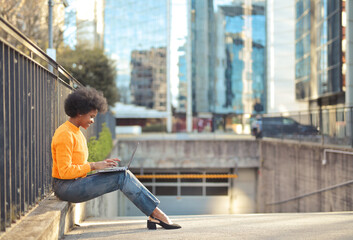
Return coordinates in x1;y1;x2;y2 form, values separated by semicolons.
119;169;234;216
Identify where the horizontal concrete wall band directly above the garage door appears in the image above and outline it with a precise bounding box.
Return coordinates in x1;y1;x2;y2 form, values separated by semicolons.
117;138;259;168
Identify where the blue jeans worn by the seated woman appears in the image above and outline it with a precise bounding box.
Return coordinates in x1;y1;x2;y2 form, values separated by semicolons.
53;170;159;216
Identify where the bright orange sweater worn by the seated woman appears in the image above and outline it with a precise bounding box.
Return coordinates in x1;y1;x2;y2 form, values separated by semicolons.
51;121;91;179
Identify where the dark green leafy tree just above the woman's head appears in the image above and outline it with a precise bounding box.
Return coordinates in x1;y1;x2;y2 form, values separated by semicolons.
57;46;119;106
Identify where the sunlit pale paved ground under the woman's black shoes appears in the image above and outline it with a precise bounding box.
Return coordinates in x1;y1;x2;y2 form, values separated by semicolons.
63;212;353;240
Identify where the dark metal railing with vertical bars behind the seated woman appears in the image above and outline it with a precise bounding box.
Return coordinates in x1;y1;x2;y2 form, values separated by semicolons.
0;16;103;231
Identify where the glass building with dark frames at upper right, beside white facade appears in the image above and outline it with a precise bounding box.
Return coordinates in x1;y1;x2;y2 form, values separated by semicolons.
295;0;346;107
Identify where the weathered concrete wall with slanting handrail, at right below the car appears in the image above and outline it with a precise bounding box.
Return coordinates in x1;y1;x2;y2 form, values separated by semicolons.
258;140;353;213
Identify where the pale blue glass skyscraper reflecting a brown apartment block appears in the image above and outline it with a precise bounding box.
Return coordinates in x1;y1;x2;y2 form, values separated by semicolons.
104;0;168;110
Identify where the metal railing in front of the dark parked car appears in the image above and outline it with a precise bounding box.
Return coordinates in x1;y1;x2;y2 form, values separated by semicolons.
263;107;353;147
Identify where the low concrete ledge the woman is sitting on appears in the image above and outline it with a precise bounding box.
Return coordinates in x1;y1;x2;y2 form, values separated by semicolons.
0;194;84;240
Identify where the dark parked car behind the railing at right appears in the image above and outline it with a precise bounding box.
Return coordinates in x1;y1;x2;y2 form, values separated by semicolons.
252;117;319;138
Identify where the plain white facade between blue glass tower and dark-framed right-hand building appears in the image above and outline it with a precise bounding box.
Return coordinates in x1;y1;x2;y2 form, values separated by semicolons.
266;0;308;113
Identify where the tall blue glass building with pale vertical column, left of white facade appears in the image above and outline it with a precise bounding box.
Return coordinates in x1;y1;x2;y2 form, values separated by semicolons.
191;0;266;115
